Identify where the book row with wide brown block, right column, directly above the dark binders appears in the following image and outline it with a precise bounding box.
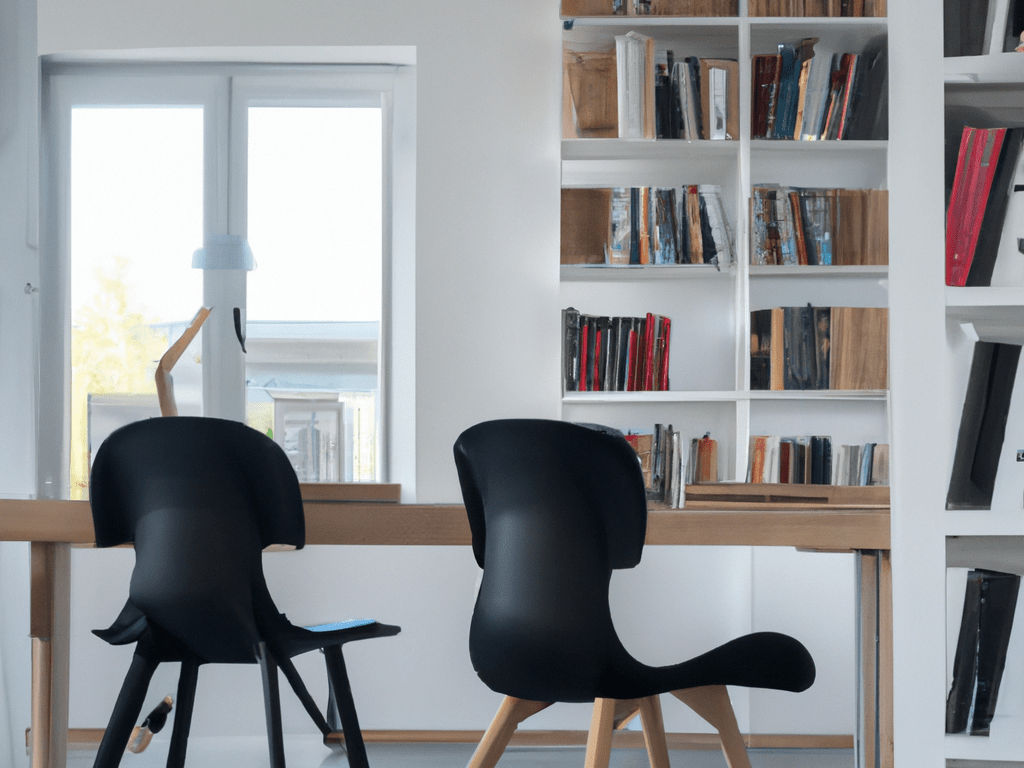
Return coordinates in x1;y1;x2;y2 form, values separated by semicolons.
751;184;889;266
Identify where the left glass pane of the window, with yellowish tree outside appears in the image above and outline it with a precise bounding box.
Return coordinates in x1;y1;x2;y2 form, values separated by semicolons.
71;106;203;499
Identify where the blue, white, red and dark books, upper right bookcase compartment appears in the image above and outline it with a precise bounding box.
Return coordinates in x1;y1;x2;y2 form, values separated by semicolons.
751;38;888;141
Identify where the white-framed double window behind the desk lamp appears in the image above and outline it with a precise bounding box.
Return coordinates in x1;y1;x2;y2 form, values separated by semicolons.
41;65;407;498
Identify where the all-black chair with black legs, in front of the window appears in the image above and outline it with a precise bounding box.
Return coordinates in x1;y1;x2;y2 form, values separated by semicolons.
89;417;399;768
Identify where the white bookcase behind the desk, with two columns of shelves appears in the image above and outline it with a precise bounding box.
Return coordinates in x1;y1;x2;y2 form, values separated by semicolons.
560;7;890;480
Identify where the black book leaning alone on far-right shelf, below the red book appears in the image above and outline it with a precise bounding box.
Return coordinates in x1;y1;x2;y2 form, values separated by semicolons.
946;341;1021;509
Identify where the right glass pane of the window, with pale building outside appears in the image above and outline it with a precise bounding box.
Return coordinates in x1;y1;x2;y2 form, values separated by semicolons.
246;108;383;481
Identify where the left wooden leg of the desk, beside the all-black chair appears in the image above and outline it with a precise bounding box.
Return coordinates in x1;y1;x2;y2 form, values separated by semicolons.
29;542;71;768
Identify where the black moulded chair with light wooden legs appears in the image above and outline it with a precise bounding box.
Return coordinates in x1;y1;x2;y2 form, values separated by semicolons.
455;420;814;768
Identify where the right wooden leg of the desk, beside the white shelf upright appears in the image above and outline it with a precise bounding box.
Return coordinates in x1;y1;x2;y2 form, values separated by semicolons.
856;551;893;768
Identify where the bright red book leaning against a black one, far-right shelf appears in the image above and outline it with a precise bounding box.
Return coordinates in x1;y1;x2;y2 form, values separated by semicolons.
946;128;1007;286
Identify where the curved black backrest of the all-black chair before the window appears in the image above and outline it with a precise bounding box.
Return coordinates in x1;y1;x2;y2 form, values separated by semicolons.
89;417;305;663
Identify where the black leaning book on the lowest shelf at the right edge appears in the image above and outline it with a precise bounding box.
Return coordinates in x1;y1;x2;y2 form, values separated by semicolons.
946;569;1021;736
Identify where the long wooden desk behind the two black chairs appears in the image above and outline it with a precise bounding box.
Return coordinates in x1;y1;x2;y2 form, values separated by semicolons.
0;494;892;768
